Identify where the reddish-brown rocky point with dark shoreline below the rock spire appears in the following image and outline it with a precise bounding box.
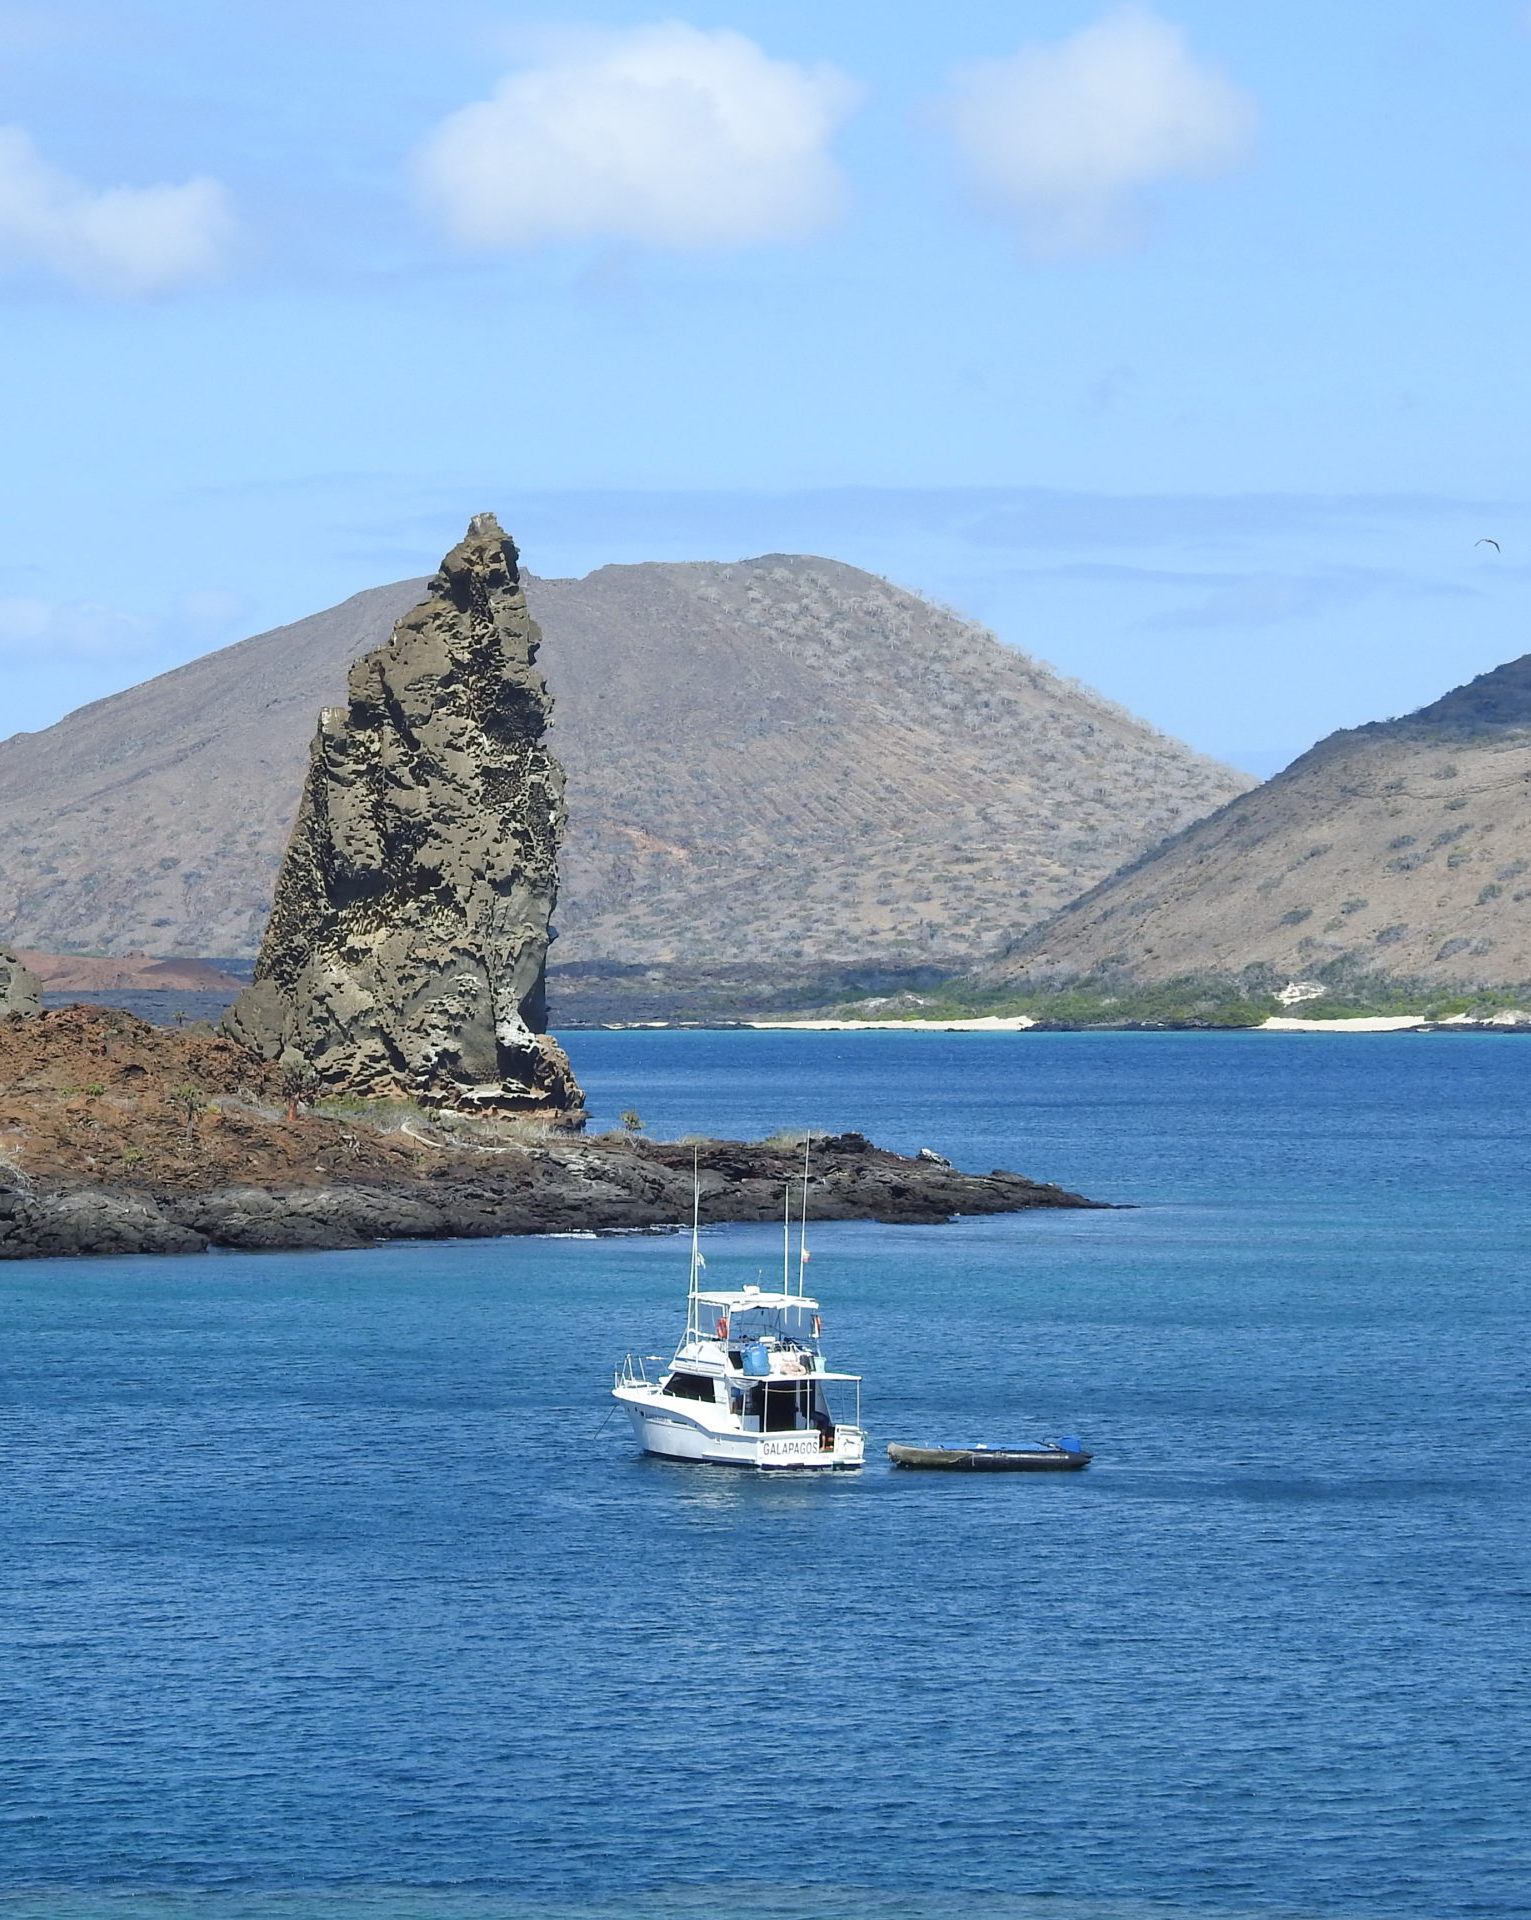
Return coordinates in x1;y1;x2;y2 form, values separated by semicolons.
0;1006;1099;1260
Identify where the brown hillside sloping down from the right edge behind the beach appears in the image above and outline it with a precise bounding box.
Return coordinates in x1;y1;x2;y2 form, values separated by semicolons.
984;655;1531;987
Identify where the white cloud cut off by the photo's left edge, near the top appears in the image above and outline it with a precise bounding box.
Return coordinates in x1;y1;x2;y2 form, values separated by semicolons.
0;127;234;296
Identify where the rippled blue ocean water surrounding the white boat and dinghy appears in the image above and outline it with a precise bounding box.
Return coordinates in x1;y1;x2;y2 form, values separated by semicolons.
0;1033;1531;1920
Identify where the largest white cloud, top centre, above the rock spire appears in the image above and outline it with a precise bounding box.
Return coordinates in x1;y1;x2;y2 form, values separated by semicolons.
417;21;857;248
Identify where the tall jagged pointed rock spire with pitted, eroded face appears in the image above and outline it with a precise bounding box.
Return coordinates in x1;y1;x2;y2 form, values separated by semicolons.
225;513;582;1114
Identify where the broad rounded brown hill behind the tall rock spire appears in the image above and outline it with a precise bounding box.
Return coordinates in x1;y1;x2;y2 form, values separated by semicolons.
0;555;1249;968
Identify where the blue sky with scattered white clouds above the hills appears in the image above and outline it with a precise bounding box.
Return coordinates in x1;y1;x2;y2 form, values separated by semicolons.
0;0;1531;772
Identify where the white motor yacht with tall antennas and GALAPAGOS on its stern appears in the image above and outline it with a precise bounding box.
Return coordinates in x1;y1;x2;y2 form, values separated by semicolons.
611;1148;866;1471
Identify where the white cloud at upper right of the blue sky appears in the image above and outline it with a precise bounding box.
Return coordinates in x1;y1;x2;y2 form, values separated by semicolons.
941;6;1254;253
